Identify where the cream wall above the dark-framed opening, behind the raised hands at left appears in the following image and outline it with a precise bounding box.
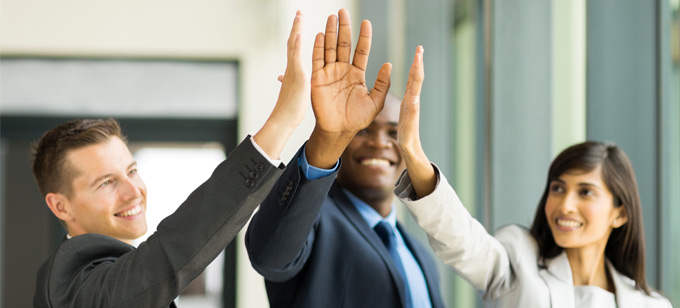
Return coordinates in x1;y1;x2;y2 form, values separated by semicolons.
0;0;360;161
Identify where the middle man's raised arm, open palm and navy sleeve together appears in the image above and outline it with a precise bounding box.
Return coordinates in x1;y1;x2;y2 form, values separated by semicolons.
246;9;391;281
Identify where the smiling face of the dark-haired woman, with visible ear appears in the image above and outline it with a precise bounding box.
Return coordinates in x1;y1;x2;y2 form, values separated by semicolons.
545;166;627;248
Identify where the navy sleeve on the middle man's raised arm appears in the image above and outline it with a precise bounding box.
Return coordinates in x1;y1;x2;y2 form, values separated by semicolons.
245;146;337;282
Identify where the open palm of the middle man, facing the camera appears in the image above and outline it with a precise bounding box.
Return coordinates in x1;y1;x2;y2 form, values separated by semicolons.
307;9;392;167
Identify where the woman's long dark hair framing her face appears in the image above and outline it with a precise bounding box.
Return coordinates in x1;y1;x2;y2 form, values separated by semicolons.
531;141;649;294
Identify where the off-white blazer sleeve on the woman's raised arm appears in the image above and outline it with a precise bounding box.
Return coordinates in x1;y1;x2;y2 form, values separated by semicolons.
394;165;515;298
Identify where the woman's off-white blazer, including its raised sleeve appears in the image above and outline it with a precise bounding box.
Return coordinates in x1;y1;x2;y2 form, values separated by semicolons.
394;166;671;308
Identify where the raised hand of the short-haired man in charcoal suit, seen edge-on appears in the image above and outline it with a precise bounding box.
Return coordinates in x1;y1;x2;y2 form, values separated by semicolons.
253;11;310;158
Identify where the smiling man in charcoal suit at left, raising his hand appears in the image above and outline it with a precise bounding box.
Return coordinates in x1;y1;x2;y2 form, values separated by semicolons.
33;12;318;307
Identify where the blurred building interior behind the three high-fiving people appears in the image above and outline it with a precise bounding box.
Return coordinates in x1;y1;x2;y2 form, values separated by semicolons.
0;0;680;307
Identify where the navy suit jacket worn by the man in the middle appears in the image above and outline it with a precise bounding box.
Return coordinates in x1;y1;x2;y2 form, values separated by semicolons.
246;147;444;308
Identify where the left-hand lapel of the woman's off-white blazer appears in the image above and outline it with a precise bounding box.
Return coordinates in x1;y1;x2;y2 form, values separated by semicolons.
539;251;575;308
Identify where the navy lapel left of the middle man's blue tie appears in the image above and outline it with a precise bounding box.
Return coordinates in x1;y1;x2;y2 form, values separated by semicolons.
329;182;406;307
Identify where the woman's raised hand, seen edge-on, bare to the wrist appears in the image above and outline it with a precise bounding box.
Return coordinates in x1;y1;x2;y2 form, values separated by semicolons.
397;46;437;198
